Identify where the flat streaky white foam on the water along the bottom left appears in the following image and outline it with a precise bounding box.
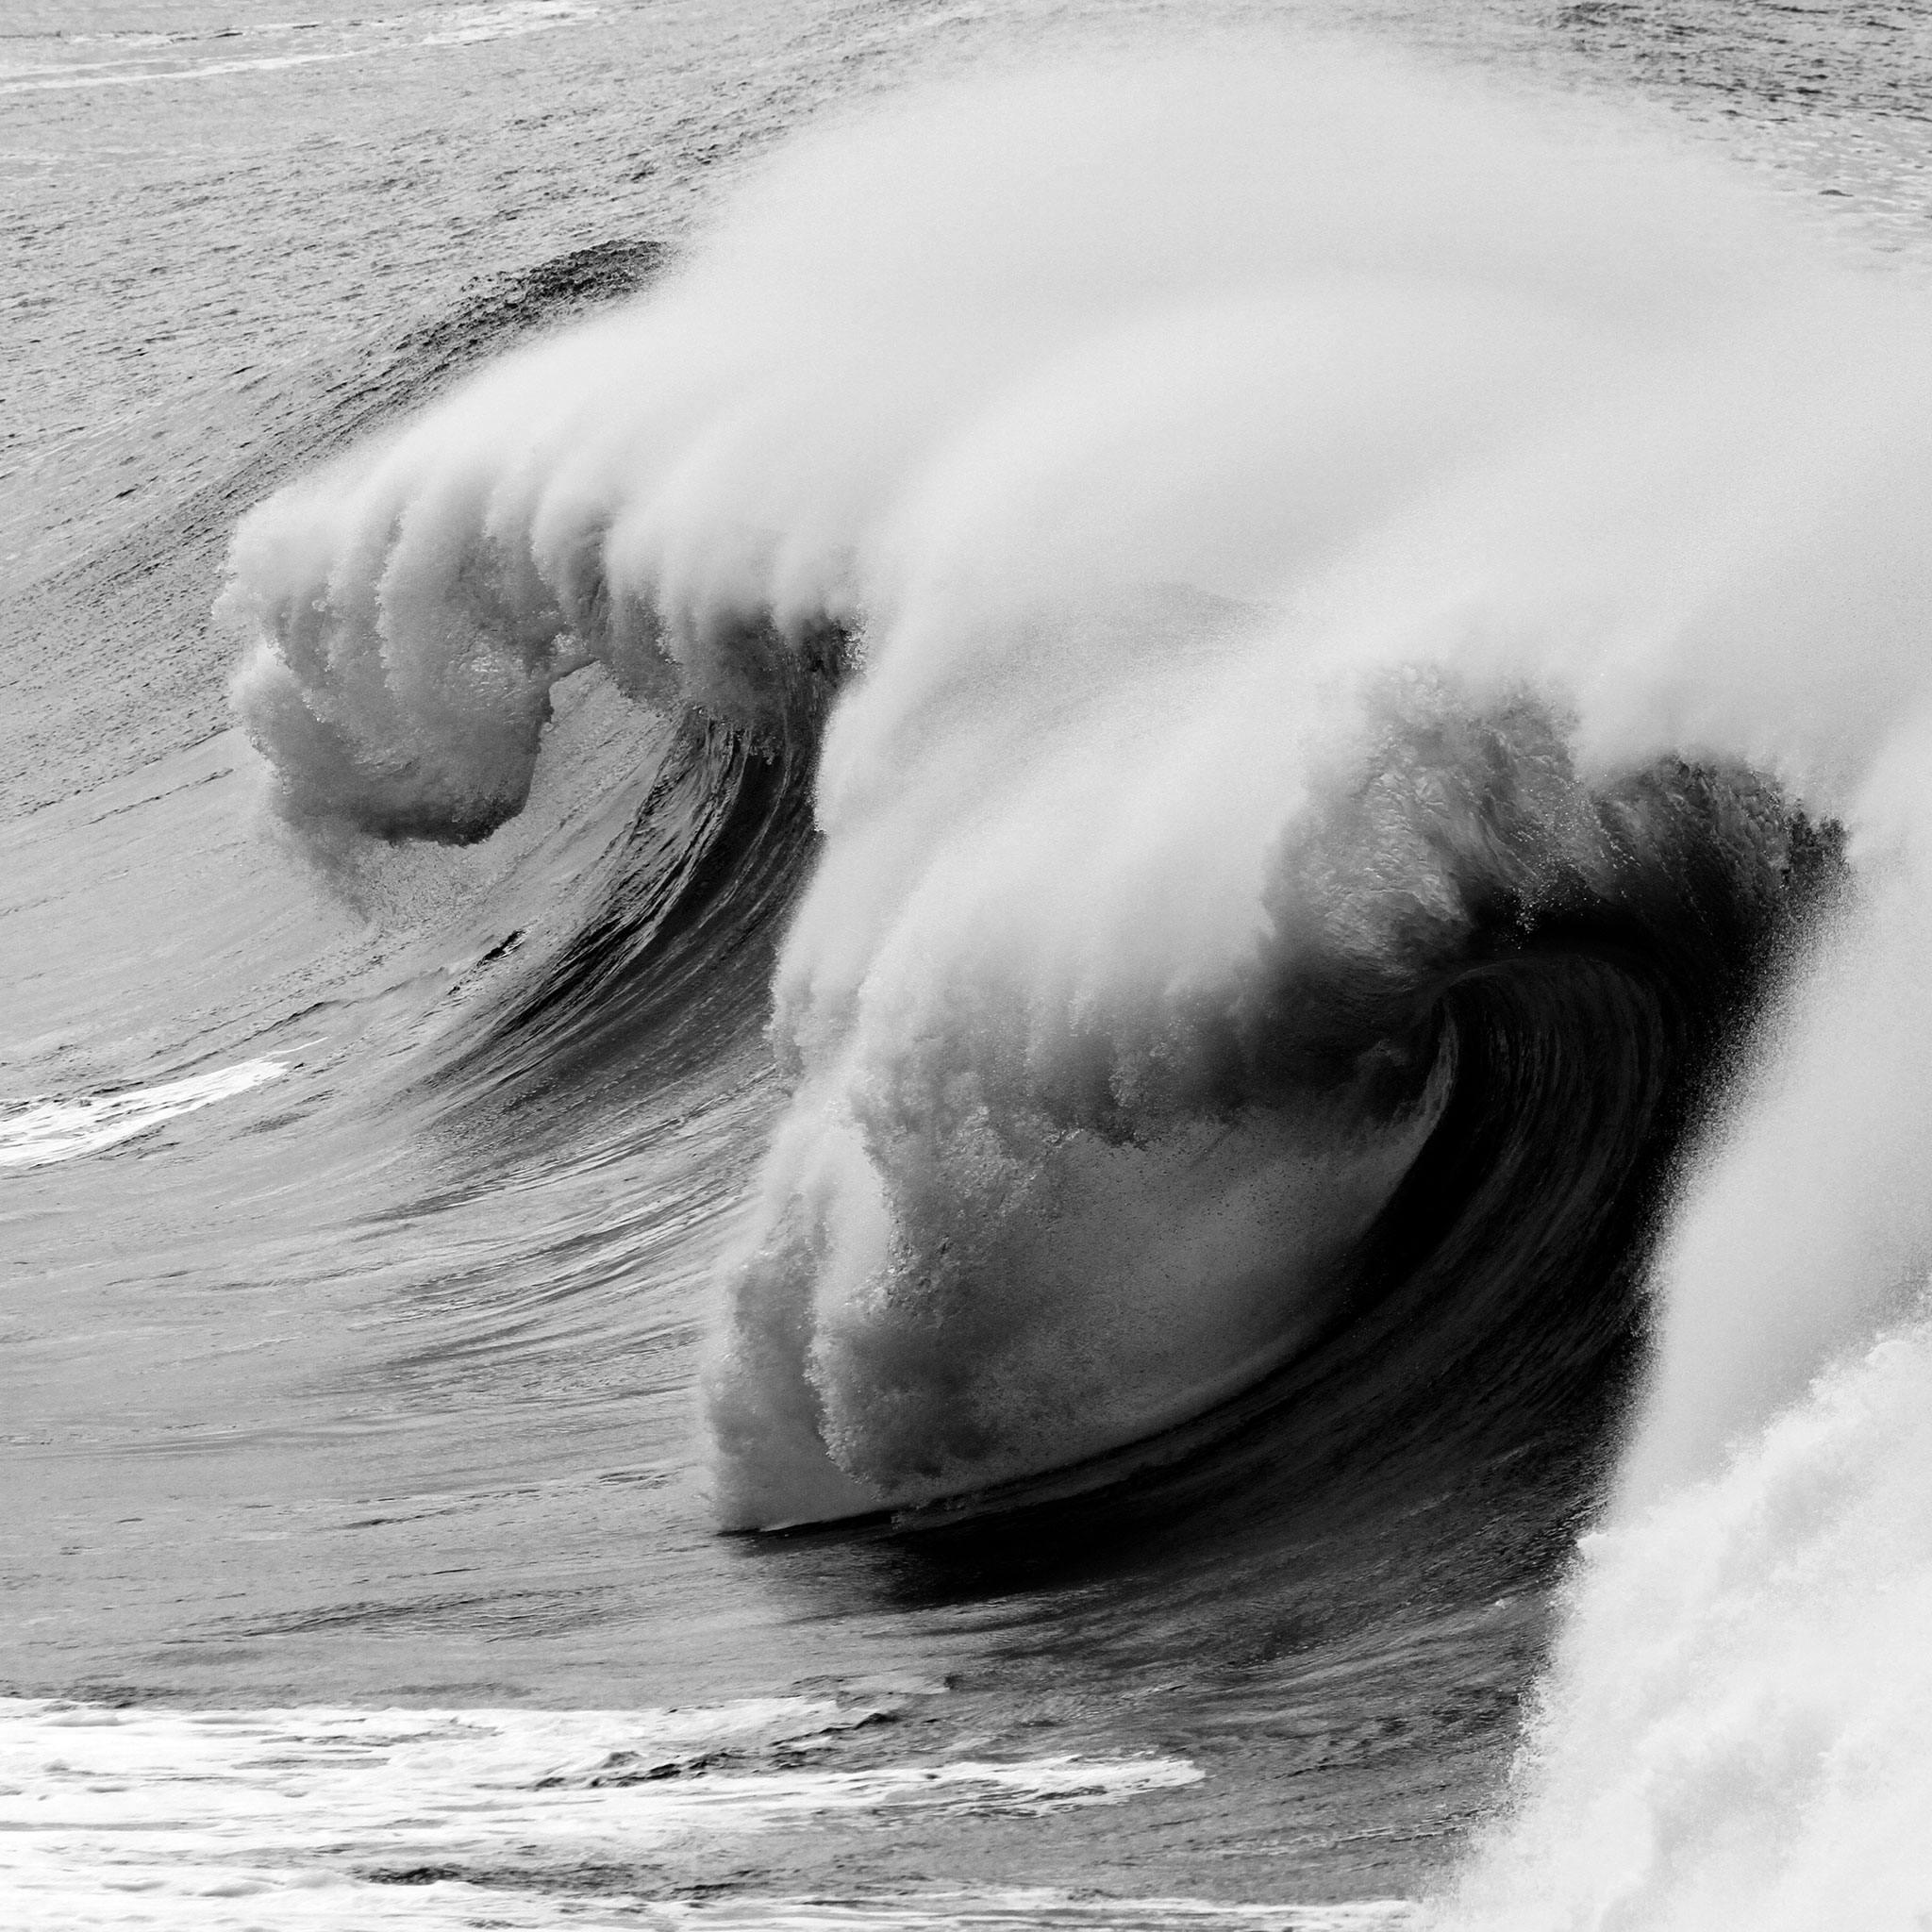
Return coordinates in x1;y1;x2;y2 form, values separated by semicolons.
0;1698;1202;1932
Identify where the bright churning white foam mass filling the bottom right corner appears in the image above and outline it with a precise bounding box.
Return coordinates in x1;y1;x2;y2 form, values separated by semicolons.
1430;1318;1932;1932
